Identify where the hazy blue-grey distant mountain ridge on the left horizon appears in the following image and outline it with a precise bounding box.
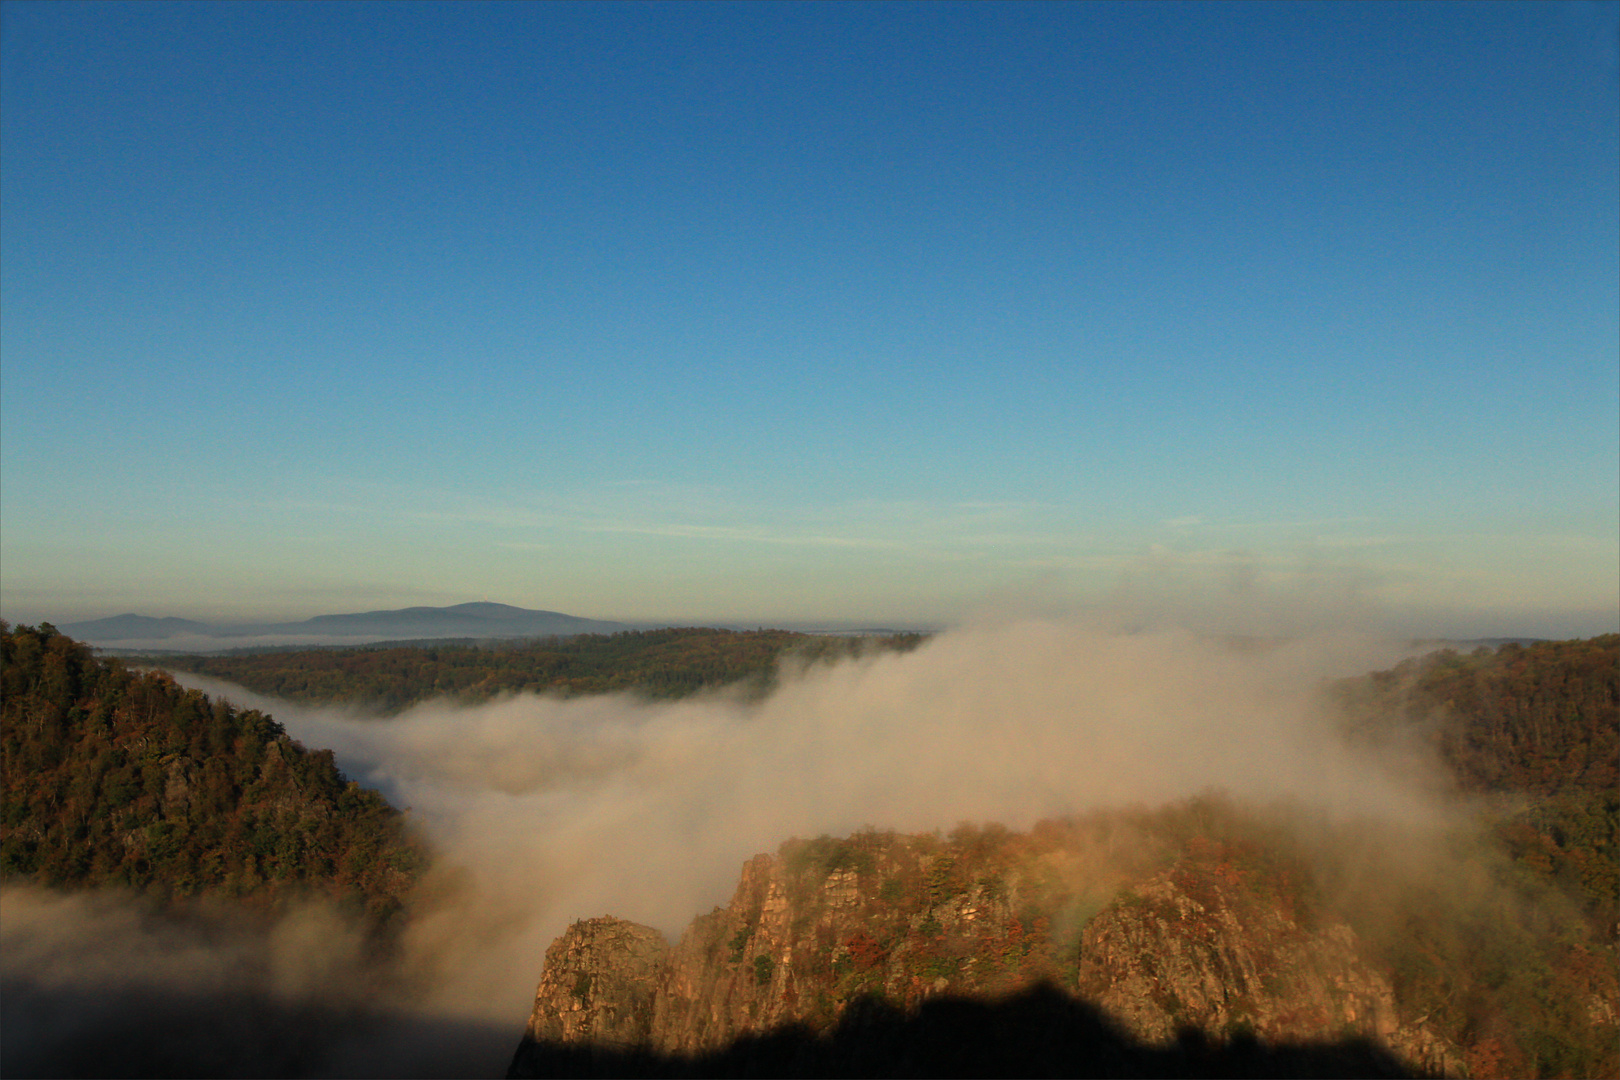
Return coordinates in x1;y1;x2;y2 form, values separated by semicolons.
62;601;630;643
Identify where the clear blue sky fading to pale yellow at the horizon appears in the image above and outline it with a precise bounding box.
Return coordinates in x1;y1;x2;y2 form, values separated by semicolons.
0;3;1620;636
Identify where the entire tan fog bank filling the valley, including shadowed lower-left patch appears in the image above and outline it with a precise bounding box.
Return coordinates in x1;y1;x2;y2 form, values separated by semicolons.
3;620;1437;1075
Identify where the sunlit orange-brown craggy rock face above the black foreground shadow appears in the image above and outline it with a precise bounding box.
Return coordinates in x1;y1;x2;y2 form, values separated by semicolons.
510;822;1455;1077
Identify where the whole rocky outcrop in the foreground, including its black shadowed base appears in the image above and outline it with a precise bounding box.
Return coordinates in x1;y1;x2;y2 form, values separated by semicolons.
509;831;1460;1077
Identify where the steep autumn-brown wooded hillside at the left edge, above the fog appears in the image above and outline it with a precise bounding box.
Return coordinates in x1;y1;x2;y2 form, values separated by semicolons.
0;623;426;928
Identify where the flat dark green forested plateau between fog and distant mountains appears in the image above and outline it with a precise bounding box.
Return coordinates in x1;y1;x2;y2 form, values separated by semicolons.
149;628;923;716
